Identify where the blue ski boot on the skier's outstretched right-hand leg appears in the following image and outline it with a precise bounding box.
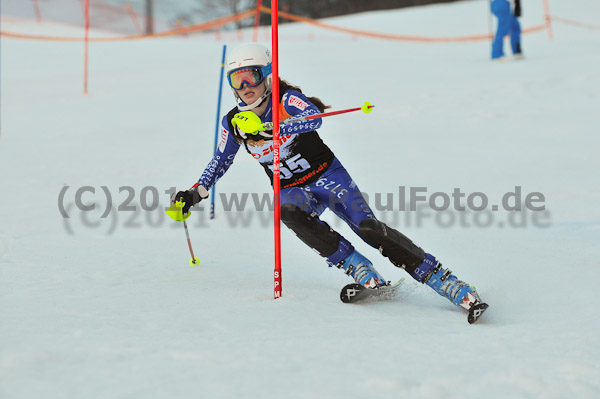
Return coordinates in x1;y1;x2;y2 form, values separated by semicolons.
413;253;488;323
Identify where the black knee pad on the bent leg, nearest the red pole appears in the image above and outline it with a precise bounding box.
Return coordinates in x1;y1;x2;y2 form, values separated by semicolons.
281;204;341;257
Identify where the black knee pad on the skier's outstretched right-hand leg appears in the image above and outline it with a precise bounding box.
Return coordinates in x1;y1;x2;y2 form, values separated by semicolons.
358;219;425;273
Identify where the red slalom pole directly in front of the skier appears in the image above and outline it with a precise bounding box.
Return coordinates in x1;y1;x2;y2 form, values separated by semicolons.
271;0;282;299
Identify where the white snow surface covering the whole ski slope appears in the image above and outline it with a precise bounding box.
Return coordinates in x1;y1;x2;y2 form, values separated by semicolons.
0;0;600;399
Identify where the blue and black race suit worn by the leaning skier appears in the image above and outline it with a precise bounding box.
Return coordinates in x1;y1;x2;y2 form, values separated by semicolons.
198;90;375;265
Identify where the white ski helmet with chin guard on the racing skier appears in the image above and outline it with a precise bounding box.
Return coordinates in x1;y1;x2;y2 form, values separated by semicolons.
225;43;273;111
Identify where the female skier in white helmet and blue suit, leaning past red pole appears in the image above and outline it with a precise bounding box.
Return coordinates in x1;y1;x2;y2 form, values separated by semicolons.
174;43;488;320
